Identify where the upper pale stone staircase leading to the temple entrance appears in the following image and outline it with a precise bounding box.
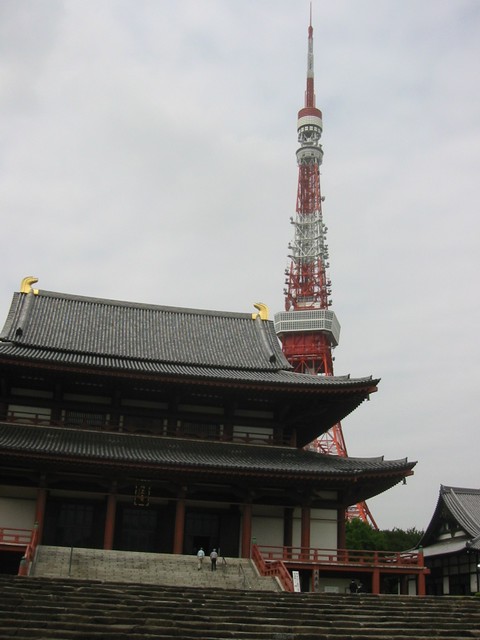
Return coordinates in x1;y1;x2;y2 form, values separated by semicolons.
30;546;281;591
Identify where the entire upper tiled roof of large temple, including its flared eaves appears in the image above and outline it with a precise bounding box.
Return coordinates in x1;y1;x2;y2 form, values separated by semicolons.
0;291;378;393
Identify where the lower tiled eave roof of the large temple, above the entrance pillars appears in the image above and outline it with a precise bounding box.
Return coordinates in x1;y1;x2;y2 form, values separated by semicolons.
0;423;416;490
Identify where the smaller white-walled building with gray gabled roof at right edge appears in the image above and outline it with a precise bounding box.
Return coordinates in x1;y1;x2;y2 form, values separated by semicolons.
419;485;480;595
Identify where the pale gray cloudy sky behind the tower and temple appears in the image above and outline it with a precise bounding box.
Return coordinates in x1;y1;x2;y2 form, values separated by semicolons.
0;0;480;529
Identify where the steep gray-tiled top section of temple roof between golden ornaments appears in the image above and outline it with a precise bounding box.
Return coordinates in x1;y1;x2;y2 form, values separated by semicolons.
0;291;291;371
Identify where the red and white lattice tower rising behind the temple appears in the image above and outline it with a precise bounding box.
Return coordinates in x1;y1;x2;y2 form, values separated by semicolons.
275;9;376;528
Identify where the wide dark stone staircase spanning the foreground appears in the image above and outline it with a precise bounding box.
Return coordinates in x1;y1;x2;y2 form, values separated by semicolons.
0;575;480;640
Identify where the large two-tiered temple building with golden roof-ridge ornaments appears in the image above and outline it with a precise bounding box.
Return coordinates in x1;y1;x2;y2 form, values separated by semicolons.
0;278;415;584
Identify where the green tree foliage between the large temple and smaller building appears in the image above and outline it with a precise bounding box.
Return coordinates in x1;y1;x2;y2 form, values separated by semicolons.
346;518;423;551
